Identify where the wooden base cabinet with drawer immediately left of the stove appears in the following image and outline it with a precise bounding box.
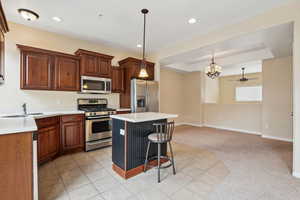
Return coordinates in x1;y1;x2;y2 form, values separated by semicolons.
61;115;84;153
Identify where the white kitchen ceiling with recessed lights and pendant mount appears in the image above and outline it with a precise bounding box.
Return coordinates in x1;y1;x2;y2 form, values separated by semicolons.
2;0;292;54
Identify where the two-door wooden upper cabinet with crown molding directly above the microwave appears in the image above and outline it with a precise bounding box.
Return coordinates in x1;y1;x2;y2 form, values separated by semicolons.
75;49;113;78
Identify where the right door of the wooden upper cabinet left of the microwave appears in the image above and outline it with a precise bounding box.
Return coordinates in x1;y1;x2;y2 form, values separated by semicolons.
55;56;80;91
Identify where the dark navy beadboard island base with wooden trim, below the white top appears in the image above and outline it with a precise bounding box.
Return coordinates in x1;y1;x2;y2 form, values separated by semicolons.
112;119;167;179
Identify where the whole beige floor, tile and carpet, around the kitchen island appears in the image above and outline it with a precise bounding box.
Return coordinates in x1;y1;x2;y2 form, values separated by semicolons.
39;126;300;200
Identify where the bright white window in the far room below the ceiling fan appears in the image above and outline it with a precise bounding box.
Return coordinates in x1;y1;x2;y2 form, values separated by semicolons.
235;86;262;102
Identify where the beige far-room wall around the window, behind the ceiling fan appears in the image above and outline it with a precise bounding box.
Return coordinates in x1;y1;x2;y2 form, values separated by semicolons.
219;73;262;104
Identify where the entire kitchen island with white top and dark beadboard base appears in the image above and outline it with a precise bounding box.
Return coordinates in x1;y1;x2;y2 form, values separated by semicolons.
111;112;178;179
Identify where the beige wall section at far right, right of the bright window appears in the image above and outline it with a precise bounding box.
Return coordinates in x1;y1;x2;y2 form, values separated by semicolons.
262;57;293;140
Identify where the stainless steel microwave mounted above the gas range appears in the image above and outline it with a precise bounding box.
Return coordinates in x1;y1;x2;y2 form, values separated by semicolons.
81;76;111;94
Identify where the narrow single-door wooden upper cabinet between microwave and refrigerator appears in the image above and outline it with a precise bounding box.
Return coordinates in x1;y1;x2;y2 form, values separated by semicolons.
111;67;124;93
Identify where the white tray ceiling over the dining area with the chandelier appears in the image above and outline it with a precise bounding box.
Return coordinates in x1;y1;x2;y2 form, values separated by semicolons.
160;23;293;72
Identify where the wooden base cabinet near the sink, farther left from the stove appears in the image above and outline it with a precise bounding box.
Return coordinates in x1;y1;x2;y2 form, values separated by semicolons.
36;117;60;163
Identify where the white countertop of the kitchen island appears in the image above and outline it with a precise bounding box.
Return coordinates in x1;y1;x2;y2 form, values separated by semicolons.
111;112;178;123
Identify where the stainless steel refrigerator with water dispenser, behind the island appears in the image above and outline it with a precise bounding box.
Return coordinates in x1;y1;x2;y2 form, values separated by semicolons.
131;79;158;112
